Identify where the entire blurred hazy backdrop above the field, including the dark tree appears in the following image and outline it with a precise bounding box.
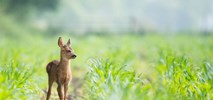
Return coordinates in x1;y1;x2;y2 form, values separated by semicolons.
0;0;213;34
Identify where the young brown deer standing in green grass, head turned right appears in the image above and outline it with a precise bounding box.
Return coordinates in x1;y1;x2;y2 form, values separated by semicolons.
46;37;77;100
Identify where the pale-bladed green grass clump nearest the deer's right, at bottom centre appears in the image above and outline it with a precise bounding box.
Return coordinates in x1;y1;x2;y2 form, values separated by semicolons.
85;60;144;100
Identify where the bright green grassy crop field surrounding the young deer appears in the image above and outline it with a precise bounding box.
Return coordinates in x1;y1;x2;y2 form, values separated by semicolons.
0;33;213;100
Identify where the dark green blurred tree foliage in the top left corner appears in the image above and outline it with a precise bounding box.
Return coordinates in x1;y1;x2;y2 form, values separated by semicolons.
0;0;60;16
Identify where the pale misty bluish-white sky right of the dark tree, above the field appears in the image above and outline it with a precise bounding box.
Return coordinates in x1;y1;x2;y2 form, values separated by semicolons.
35;0;213;33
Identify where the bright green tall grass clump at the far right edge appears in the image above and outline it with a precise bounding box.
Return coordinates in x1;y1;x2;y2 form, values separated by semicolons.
156;55;213;99
